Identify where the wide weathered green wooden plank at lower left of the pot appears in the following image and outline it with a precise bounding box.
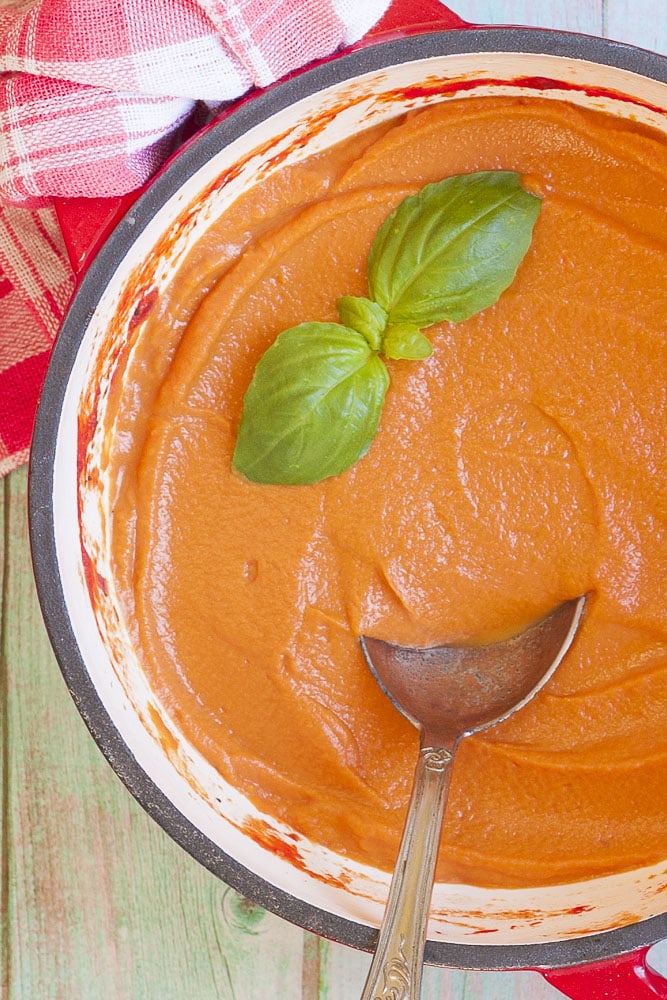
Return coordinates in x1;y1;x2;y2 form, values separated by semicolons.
2;470;303;1000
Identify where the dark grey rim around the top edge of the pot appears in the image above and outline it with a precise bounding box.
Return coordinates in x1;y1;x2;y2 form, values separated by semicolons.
28;26;667;970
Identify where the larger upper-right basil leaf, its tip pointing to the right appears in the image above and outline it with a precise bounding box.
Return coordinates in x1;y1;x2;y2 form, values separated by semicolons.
368;171;541;327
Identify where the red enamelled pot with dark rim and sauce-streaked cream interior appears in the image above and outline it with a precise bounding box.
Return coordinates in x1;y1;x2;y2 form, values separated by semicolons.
30;0;667;1000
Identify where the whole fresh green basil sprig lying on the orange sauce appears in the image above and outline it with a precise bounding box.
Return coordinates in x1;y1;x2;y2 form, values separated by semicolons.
233;171;541;485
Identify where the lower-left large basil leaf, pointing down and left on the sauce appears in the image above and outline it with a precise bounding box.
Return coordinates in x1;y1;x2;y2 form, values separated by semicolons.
232;323;389;485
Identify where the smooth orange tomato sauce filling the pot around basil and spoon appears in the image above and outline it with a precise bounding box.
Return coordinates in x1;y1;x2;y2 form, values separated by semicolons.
107;98;667;886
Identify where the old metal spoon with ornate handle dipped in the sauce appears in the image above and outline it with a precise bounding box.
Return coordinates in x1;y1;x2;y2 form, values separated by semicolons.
360;596;586;1000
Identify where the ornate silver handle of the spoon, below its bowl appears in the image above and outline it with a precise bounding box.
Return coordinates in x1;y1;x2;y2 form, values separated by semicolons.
361;747;452;1000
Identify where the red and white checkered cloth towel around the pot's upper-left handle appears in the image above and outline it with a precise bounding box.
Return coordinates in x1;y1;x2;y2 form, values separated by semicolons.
0;0;389;475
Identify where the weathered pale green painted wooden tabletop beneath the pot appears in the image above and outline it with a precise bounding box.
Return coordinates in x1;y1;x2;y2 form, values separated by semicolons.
0;0;667;1000
